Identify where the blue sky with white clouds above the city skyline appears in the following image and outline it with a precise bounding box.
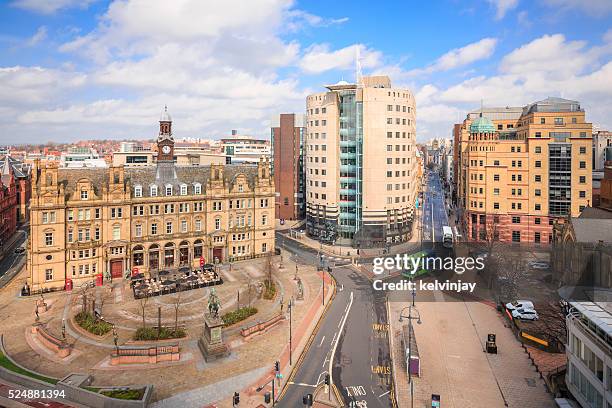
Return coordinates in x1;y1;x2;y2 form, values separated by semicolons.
0;0;612;144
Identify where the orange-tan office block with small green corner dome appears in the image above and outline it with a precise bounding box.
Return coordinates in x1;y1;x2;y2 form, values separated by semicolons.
458;98;592;243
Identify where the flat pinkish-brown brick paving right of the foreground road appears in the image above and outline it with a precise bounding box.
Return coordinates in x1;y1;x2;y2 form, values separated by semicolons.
389;294;555;408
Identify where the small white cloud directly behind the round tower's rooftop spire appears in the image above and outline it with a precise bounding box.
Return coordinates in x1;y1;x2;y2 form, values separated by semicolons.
299;44;382;74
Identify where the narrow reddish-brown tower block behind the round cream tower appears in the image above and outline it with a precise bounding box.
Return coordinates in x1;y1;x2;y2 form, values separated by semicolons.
270;113;306;220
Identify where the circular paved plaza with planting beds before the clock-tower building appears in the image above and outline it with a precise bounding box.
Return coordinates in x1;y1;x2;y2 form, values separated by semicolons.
0;255;330;407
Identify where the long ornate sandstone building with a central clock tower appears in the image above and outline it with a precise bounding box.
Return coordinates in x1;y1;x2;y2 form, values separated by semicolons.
27;111;274;291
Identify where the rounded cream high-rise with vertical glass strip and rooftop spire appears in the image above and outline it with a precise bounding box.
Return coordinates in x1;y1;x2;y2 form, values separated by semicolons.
306;76;417;247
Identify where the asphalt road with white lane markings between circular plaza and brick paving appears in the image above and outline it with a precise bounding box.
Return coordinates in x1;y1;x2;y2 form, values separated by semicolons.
277;234;392;408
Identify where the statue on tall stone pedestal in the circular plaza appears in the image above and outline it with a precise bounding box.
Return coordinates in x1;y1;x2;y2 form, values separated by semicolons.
198;288;229;362
